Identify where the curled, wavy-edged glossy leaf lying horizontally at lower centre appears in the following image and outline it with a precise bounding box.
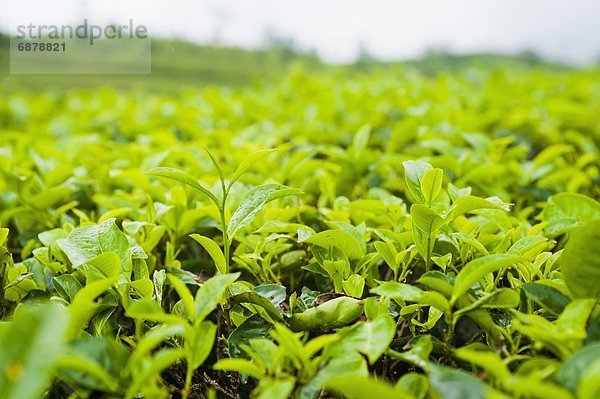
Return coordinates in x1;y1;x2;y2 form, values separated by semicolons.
289;296;362;331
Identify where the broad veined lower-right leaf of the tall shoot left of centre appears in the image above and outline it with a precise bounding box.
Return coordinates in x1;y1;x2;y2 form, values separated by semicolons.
227;184;302;241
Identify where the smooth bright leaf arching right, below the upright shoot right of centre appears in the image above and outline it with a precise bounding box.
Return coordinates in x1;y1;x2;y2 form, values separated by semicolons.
450;254;523;304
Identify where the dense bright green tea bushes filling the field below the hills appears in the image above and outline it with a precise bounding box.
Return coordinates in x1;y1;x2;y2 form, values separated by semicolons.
0;69;600;399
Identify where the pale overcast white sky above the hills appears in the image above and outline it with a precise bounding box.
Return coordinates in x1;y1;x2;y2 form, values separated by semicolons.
0;0;600;64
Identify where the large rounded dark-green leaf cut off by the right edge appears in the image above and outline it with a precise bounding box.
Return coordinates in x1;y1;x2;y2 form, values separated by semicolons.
560;220;600;298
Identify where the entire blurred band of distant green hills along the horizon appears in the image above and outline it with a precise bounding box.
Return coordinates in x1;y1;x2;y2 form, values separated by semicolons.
0;34;567;92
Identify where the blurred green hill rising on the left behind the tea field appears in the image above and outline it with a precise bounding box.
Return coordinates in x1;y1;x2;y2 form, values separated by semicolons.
0;34;324;91
